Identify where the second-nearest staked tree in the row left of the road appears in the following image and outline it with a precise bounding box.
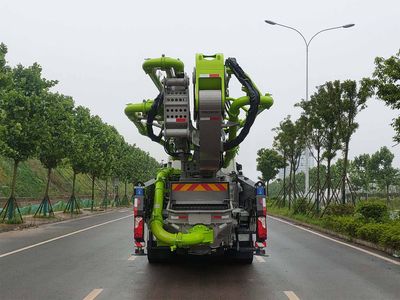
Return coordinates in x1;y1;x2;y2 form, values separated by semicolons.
35;93;74;216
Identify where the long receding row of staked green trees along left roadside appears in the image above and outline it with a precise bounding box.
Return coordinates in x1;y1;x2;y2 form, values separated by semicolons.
0;44;159;222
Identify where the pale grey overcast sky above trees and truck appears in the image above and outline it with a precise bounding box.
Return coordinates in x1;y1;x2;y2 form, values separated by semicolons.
0;0;400;179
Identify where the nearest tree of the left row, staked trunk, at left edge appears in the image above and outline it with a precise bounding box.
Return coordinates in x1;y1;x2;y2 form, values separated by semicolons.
0;62;57;222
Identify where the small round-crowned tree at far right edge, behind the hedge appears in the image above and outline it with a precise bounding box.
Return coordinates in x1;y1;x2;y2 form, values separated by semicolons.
370;147;400;204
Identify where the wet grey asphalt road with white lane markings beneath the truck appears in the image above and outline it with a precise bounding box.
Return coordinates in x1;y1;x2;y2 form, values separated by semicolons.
0;209;400;300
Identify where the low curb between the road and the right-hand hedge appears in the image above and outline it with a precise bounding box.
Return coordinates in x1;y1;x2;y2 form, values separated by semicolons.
268;213;400;258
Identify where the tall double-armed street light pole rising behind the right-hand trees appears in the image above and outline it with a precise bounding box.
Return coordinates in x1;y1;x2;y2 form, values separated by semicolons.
265;20;355;195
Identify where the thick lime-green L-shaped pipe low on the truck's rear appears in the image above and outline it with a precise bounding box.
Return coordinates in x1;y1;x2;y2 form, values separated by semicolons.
150;168;214;250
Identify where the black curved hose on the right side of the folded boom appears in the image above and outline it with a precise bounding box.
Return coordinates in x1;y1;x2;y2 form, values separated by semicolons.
224;58;260;151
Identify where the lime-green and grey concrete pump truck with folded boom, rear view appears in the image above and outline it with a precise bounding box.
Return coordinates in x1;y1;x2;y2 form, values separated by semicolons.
125;54;273;263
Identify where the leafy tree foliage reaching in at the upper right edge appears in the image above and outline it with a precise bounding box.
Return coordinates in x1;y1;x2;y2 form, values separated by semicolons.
373;50;400;143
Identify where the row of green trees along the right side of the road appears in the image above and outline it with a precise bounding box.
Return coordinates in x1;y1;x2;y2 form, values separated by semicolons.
257;48;400;212
